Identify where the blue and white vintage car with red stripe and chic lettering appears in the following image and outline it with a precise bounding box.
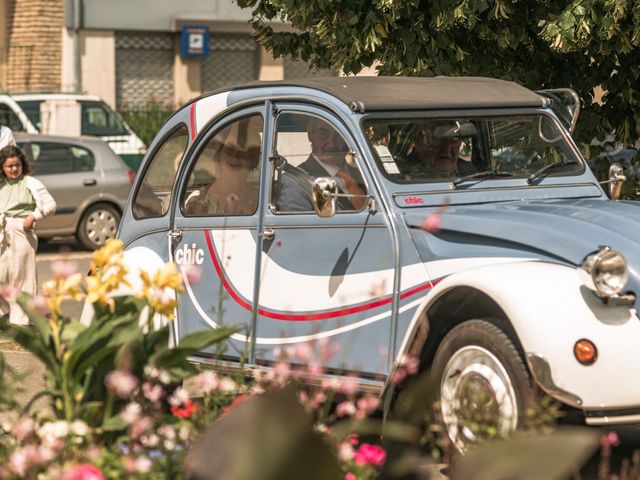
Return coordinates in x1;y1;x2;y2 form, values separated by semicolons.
119;77;640;444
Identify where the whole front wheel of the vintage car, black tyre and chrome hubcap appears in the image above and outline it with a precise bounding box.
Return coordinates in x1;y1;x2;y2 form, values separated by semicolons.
433;320;534;451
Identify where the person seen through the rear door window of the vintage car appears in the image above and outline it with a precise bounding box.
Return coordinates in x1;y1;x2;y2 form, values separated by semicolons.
185;120;261;215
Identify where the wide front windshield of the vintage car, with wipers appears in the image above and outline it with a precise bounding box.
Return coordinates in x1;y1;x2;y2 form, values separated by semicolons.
359;109;586;185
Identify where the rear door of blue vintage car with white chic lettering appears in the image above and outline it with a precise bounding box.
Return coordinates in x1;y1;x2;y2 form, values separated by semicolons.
171;107;264;360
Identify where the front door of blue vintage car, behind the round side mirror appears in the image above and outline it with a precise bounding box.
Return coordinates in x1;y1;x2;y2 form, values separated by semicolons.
255;107;395;377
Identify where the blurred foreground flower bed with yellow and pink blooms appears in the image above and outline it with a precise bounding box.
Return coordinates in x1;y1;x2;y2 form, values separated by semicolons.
0;240;618;480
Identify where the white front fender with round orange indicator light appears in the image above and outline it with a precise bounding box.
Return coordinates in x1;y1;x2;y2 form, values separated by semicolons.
405;261;640;408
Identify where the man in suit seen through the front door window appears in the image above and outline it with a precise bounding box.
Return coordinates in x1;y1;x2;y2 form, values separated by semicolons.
278;117;367;211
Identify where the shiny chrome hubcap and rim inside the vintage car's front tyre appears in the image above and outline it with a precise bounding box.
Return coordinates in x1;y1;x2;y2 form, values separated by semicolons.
440;346;518;451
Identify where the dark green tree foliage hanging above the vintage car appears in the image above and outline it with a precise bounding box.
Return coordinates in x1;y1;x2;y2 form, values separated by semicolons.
238;0;640;144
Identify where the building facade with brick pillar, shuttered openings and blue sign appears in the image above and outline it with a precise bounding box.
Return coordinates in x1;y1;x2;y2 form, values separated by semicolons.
0;0;336;108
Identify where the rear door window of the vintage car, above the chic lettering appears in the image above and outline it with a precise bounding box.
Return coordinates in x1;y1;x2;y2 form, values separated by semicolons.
180;115;263;216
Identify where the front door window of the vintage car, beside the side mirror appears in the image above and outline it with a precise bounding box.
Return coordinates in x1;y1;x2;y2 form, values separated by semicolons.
270;112;367;213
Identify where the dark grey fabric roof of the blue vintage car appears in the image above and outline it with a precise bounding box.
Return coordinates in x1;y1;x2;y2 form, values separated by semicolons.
210;76;547;112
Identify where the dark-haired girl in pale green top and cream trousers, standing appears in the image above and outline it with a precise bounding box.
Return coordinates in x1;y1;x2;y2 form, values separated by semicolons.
0;146;56;325
